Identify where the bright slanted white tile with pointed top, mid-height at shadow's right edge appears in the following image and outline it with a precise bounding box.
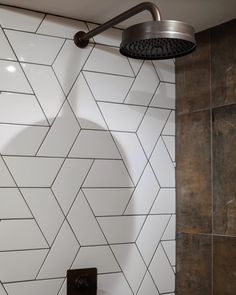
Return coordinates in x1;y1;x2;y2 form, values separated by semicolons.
125;164;159;215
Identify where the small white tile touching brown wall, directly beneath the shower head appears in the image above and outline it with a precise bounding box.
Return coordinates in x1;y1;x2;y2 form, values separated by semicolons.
153;59;175;83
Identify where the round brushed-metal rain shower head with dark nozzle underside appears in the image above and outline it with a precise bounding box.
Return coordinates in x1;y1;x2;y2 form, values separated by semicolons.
120;20;196;60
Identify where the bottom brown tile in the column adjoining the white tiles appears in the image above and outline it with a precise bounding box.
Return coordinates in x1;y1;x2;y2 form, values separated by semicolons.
176;234;211;295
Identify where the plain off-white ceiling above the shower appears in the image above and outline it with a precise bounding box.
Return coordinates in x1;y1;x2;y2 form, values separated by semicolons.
1;0;236;31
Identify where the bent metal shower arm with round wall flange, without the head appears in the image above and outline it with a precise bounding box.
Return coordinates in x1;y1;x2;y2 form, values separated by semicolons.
74;2;161;48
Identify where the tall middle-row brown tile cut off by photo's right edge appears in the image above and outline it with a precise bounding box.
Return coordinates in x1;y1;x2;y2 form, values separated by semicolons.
213;104;236;236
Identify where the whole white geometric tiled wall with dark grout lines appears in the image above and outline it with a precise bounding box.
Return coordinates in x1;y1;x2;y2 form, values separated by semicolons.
0;5;175;295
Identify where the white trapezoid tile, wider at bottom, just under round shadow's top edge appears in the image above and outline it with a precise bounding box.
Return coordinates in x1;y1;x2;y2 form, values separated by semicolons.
69;130;121;159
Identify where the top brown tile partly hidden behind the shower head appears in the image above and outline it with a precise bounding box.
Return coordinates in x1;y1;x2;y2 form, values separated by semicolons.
176;31;210;114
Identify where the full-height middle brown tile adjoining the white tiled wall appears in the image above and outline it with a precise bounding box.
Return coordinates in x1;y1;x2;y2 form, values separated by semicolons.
176;111;212;233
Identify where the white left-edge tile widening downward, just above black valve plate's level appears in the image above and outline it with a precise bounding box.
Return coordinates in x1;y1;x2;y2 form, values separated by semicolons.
0;219;48;251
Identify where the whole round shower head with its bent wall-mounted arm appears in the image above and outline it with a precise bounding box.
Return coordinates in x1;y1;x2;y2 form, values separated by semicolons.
74;2;196;60
